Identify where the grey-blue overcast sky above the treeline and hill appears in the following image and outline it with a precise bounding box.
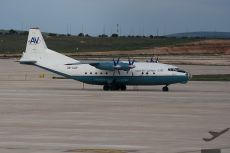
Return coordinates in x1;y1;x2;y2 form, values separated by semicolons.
0;0;230;35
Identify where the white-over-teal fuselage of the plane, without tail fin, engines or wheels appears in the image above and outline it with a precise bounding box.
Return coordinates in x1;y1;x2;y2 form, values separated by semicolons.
35;55;189;85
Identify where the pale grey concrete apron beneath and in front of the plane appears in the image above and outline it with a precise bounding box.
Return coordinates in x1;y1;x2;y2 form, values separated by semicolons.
0;60;230;153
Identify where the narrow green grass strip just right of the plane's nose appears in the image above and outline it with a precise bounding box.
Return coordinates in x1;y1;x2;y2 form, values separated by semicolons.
191;74;230;81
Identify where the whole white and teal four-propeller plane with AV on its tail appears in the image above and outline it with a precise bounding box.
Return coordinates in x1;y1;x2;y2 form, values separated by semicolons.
20;28;191;91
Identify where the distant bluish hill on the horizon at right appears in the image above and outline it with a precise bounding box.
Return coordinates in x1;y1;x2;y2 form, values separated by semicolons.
166;31;230;39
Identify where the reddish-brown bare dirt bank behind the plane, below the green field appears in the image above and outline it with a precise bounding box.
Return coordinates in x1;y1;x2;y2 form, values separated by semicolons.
64;39;230;57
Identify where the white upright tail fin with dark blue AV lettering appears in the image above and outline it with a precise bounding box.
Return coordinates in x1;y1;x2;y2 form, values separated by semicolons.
20;28;78;65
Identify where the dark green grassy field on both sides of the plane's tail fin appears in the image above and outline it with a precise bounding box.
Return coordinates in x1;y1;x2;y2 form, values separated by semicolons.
0;30;199;54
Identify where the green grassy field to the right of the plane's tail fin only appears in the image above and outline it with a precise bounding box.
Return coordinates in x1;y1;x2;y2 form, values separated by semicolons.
46;36;198;52
